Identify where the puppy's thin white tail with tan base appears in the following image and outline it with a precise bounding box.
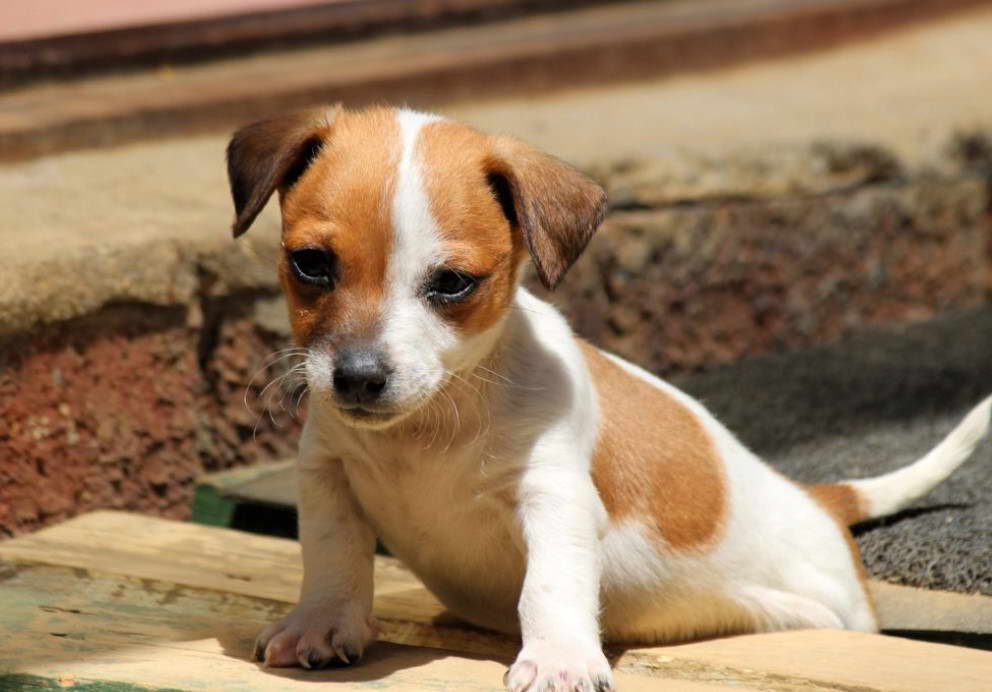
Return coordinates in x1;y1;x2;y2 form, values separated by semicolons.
806;396;992;525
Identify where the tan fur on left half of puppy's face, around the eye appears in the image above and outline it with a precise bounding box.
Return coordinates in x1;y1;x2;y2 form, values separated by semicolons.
280;108;401;344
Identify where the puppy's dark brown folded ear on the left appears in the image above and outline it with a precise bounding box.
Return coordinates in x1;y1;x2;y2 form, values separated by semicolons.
227;105;342;238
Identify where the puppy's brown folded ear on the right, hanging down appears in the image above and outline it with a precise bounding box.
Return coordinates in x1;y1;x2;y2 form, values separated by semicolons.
487;135;606;289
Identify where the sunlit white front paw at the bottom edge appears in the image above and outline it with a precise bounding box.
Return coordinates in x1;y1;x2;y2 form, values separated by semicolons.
503;642;614;692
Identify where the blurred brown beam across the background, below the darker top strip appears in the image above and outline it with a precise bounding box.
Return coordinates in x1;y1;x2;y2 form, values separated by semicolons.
0;0;988;160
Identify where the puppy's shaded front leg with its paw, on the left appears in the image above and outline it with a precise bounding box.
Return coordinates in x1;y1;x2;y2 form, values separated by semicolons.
255;430;375;668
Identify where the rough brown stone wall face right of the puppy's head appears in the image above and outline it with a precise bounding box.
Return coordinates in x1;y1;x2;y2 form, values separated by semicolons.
552;178;990;374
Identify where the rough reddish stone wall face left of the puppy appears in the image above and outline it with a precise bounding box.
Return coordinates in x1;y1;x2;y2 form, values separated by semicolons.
0;294;299;535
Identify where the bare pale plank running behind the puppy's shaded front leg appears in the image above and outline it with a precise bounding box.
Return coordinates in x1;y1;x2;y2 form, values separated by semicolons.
0;512;496;653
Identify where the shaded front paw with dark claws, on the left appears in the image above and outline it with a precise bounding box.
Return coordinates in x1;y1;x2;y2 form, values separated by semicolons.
254;603;377;668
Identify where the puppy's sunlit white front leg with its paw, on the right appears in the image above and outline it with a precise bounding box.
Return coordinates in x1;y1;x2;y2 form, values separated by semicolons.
505;468;613;692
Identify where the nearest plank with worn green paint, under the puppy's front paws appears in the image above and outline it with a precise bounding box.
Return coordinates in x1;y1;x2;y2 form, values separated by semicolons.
0;565;721;692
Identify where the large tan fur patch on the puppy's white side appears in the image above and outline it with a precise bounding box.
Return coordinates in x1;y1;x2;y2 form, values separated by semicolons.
579;341;727;550
